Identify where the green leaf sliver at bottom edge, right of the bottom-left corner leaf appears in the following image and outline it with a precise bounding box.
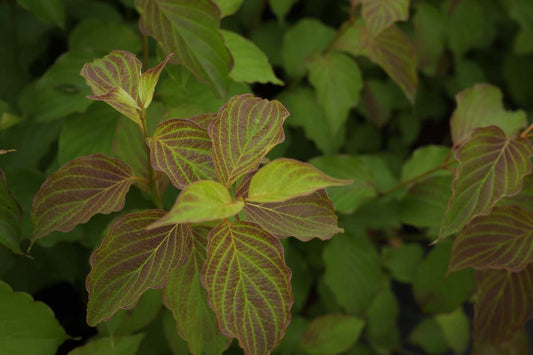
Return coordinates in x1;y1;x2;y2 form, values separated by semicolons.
68;333;144;355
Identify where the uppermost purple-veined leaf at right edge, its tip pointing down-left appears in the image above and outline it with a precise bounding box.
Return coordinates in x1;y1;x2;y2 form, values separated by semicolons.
439;126;533;239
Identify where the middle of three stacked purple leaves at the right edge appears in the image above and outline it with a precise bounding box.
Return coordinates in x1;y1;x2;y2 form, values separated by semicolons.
448;206;533;272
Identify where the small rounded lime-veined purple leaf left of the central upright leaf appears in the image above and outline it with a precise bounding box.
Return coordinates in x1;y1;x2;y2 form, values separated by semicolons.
146;119;216;189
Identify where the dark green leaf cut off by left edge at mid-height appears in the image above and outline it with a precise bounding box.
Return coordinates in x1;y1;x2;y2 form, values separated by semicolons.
0;169;22;254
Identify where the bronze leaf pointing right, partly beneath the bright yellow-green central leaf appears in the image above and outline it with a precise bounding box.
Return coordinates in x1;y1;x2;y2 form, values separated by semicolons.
244;190;343;242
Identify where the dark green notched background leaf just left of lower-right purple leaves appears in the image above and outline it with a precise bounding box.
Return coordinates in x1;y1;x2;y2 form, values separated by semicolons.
413;240;475;313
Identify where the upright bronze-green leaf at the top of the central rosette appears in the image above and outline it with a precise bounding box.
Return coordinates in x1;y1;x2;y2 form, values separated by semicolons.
207;94;289;186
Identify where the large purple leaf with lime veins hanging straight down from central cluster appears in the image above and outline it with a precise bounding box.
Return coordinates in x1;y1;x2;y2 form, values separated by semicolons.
202;221;293;354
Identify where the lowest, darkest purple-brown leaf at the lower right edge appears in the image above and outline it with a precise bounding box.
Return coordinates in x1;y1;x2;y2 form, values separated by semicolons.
473;264;533;343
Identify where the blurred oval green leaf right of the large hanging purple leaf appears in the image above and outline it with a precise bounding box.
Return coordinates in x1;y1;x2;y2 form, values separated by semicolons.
323;235;383;315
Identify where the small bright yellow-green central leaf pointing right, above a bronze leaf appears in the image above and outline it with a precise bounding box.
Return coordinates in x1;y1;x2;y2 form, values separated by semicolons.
247;158;353;202
